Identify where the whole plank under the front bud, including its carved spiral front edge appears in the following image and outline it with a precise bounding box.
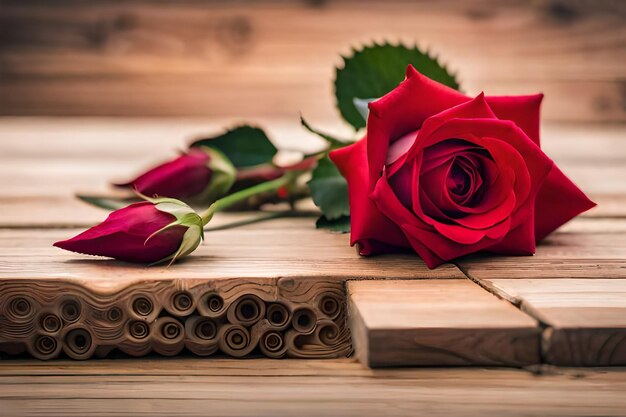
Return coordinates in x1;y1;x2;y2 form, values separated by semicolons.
0;219;463;359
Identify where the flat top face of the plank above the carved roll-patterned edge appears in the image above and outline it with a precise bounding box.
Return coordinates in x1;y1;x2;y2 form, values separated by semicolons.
0;217;464;282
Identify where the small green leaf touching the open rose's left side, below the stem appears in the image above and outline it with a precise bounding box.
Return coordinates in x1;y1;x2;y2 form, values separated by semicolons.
307;156;350;220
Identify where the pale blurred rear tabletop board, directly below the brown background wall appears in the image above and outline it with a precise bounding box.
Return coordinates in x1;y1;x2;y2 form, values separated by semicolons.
0;117;626;227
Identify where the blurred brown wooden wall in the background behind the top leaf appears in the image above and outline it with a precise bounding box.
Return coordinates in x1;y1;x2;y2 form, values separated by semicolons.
0;0;626;122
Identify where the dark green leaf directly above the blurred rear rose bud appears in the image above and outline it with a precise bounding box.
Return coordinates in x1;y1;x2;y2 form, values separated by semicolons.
190;125;277;168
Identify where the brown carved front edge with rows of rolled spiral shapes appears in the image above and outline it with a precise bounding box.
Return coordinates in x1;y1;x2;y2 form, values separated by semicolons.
0;278;352;359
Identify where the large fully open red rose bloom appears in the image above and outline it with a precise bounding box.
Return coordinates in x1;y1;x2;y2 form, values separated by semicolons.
331;66;595;268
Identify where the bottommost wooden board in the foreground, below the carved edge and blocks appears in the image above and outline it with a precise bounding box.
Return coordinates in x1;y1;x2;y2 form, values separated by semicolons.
0;358;626;417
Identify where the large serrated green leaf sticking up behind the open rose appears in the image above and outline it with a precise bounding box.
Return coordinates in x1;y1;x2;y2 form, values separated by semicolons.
335;43;459;130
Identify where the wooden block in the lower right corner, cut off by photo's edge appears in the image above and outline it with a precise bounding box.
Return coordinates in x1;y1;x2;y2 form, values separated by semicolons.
488;278;626;366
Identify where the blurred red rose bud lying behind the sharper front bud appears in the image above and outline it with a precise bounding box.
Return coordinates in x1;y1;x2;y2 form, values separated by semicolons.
116;146;236;203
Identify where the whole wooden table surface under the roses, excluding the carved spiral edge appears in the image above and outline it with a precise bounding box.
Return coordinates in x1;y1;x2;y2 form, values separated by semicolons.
0;118;626;416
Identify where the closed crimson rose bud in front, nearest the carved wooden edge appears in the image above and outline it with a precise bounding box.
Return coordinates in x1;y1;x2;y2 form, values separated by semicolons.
54;198;203;263
